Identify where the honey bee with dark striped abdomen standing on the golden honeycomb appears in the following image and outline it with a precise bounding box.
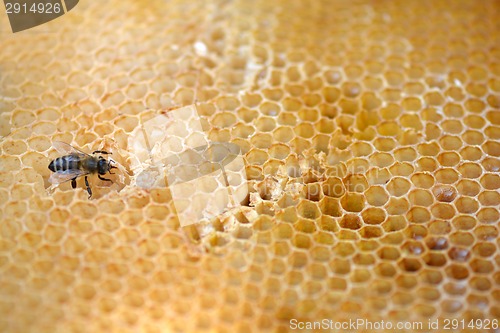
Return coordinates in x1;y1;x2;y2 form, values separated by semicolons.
49;141;117;199
